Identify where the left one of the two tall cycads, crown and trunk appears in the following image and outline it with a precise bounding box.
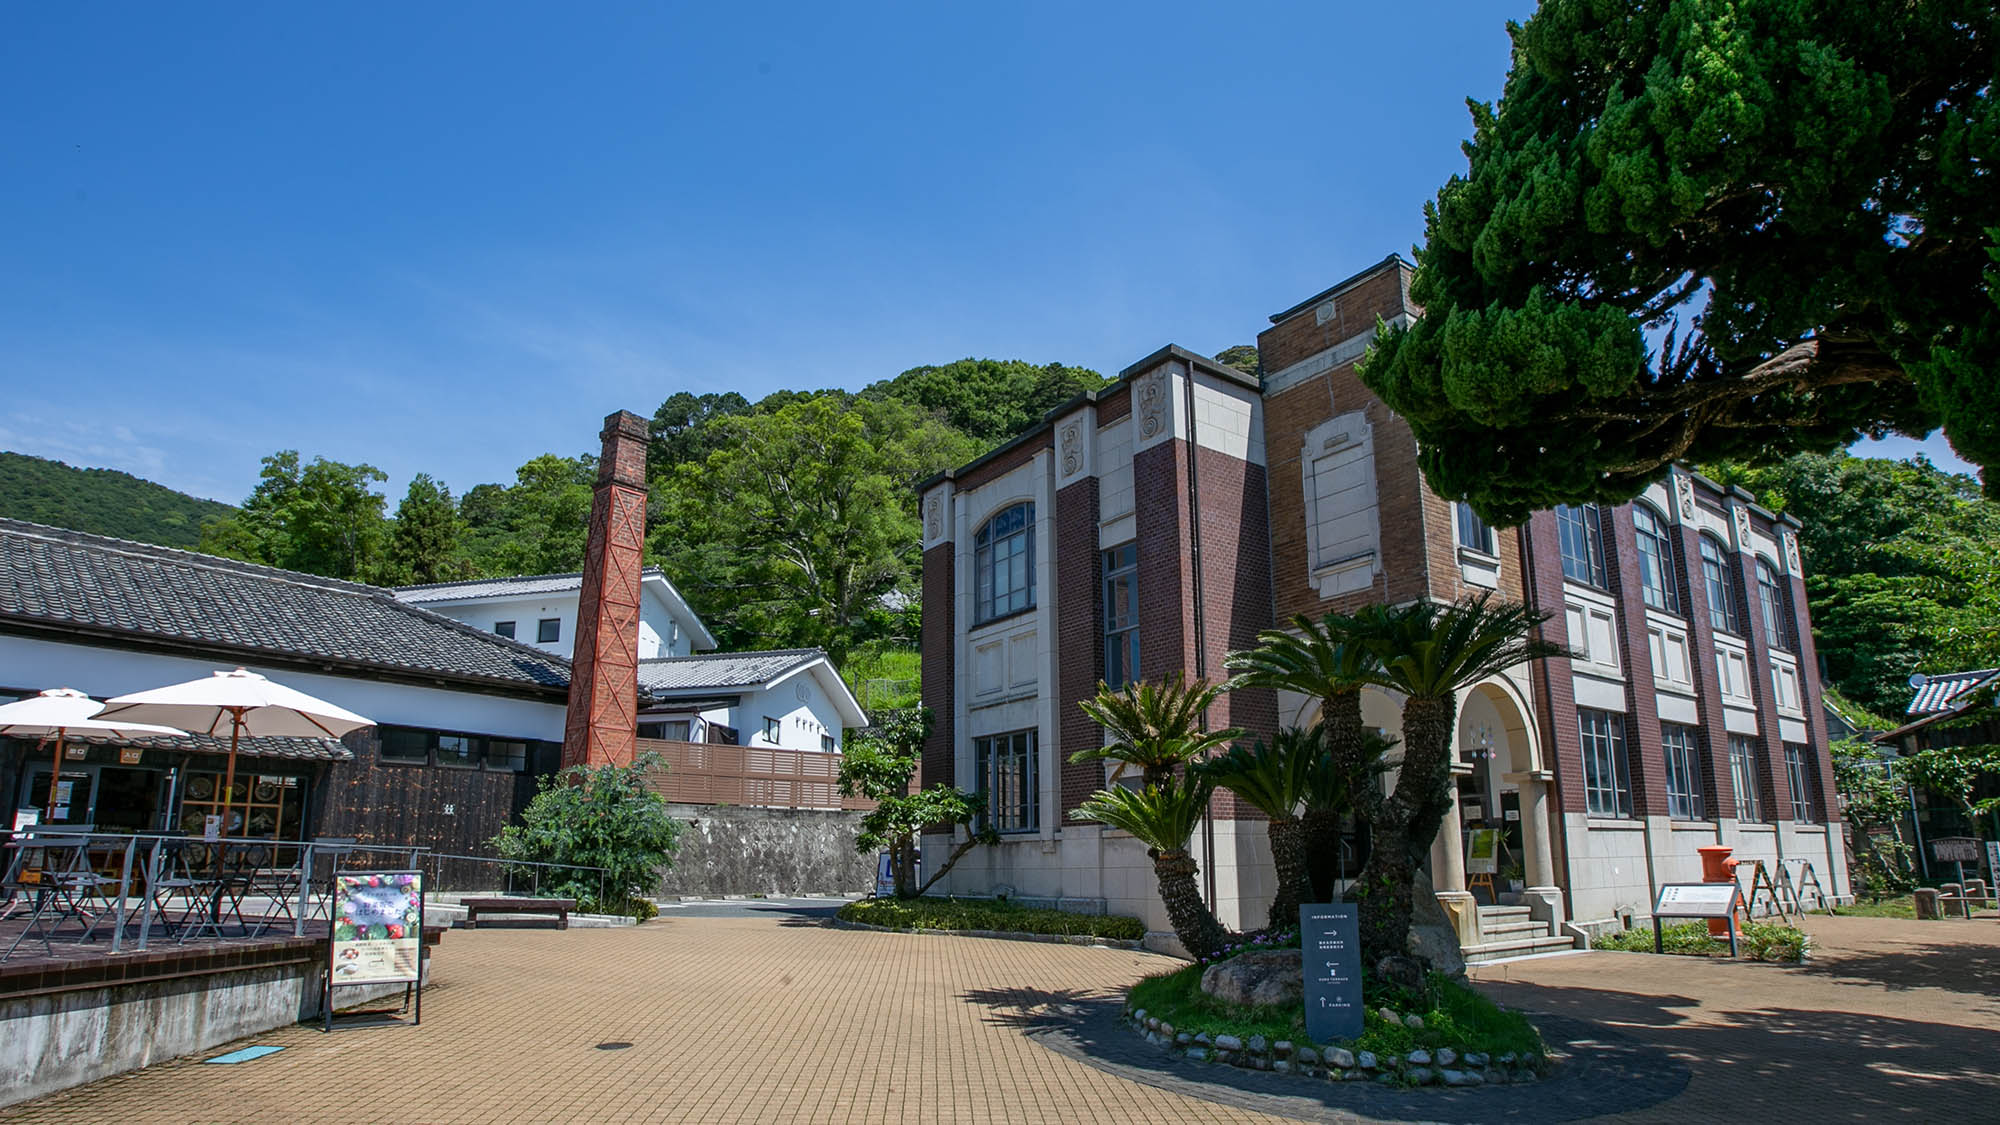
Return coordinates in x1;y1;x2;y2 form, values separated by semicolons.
1224;613;1382;901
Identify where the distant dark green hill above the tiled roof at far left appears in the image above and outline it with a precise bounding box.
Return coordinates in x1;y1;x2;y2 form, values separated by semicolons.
0;452;236;546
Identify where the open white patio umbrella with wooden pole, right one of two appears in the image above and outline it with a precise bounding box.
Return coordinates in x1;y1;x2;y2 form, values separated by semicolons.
104;669;374;833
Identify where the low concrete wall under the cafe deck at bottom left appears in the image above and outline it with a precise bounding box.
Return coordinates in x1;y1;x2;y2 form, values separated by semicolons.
0;957;410;1105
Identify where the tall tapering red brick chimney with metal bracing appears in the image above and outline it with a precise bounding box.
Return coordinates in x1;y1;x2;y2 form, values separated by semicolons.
562;410;646;769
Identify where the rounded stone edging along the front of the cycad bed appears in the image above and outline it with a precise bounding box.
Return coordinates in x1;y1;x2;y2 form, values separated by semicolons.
1126;1009;1548;1087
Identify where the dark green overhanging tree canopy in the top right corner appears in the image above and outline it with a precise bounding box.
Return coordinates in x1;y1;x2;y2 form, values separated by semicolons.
1362;0;2000;524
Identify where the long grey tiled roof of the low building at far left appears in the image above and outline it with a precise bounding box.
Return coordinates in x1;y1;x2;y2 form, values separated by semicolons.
0;520;570;695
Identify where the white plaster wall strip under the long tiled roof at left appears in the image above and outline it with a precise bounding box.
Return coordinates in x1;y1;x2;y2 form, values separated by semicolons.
0;637;564;743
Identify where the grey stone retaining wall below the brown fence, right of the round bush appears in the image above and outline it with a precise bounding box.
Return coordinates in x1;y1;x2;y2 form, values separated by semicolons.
660;805;874;895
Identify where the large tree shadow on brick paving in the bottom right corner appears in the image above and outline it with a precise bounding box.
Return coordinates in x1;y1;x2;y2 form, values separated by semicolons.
1482;981;2000;1121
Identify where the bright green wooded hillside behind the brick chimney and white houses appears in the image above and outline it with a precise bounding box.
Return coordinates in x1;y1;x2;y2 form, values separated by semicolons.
180;358;1104;663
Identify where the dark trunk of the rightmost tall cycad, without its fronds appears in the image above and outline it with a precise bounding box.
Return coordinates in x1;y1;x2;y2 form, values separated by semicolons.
1354;695;1458;965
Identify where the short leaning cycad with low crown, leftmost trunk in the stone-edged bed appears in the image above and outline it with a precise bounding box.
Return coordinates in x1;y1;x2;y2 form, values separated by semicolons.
1070;773;1230;961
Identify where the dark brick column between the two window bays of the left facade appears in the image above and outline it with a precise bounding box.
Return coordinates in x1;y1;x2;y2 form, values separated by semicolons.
1048;476;1104;812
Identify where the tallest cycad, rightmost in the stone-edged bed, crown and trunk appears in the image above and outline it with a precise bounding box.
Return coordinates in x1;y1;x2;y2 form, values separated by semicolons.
1354;595;1566;965
